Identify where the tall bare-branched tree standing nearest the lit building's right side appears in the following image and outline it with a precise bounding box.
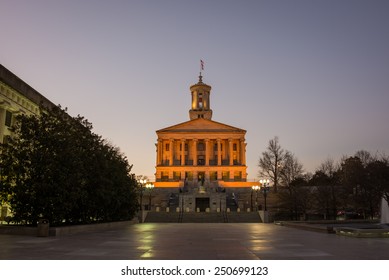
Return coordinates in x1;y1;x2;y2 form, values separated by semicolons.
258;136;285;192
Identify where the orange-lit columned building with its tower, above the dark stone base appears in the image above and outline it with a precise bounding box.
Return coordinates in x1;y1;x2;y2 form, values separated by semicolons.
155;74;252;188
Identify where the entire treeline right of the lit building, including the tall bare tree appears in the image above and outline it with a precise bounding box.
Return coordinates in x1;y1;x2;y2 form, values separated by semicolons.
258;137;389;220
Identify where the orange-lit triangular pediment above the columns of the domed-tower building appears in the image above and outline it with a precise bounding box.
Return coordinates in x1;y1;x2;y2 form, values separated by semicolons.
157;118;246;133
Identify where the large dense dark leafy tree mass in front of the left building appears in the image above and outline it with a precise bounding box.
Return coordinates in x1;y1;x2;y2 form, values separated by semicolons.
0;107;137;225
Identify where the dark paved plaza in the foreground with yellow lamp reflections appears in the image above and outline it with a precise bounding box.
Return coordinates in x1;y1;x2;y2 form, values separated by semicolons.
0;223;389;260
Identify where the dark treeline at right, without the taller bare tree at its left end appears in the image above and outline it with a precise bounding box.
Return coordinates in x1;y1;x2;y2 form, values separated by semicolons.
278;151;389;220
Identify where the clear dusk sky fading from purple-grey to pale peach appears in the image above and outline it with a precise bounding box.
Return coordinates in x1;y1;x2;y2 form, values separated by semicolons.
0;0;389;179
